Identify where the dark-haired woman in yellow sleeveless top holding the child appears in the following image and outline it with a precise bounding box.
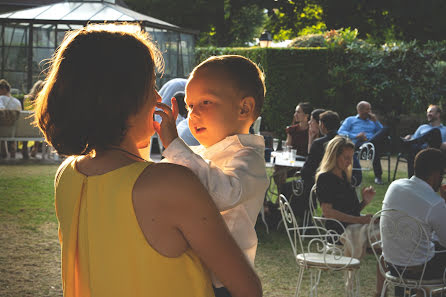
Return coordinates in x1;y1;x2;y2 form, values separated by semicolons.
35;24;262;297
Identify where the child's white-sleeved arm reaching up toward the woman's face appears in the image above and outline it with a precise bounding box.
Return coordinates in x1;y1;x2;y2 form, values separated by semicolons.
163;138;268;211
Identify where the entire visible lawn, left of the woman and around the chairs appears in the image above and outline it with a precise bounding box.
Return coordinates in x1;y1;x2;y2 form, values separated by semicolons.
0;160;410;297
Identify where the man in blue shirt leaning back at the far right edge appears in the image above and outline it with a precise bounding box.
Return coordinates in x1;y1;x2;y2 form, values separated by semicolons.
402;104;446;178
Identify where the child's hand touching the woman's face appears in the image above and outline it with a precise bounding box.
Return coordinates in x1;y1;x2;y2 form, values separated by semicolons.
153;97;178;148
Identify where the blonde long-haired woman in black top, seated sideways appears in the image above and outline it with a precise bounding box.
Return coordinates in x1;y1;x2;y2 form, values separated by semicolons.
316;136;384;296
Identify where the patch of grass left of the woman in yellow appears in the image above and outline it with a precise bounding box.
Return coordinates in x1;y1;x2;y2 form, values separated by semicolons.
0;165;62;297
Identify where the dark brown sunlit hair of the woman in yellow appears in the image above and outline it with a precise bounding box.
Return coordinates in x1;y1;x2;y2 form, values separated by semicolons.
35;24;162;155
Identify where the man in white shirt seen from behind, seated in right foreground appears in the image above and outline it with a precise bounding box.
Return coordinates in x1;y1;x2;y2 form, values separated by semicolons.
381;148;446;279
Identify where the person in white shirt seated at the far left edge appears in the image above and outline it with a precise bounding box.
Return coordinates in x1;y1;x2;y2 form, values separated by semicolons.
0;79;22;158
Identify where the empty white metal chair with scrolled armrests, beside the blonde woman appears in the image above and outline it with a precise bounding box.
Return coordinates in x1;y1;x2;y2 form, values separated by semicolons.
279;195;360;297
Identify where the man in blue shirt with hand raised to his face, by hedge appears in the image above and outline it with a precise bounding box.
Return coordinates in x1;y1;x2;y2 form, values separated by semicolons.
338;101;388;185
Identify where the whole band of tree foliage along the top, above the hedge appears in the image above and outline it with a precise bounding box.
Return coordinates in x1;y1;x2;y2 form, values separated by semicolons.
126;0;446;46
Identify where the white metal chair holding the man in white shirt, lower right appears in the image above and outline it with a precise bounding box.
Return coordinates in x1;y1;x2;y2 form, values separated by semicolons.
368;209;446;297
